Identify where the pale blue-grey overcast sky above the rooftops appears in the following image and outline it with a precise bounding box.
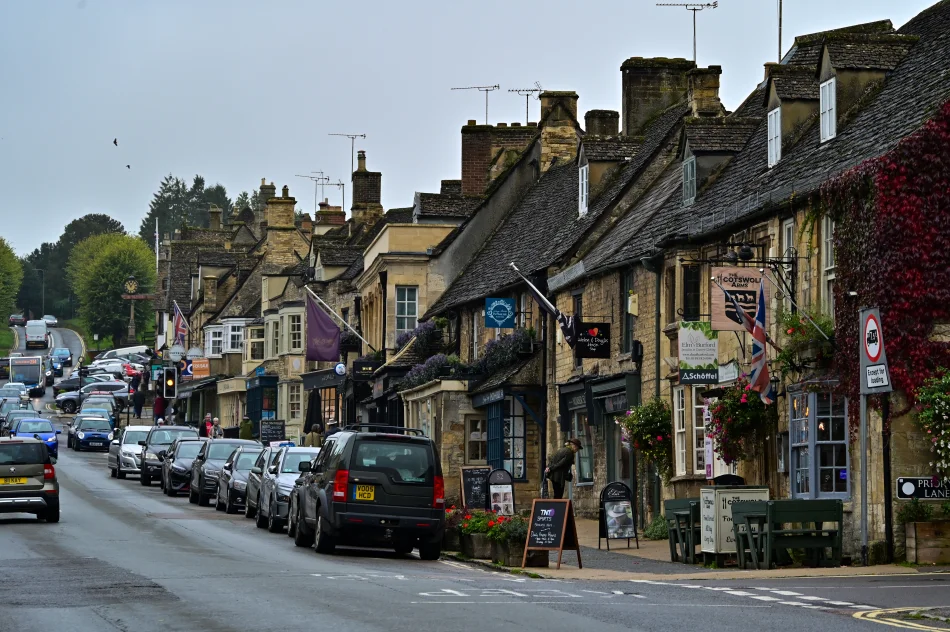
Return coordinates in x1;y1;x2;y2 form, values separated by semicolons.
0;0;936;256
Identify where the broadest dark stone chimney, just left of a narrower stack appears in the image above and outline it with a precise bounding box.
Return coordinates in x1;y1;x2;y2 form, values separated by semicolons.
620;57;696;136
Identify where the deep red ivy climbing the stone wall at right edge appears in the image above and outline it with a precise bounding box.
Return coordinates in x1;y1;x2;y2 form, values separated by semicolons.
821;102;950;432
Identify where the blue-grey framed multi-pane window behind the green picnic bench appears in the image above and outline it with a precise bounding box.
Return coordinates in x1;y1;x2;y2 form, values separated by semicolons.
789;393;851;499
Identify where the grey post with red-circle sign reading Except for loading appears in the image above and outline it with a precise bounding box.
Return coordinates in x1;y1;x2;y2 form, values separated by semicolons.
858;307;893;566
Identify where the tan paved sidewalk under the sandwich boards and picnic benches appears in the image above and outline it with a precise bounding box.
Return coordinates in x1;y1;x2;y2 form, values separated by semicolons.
447;518;918;581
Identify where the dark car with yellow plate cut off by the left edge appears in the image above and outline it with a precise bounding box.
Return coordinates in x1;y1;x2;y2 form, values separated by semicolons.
0;437;59;522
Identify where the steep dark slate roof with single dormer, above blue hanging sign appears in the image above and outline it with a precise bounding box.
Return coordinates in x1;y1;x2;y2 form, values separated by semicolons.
423;103;689;318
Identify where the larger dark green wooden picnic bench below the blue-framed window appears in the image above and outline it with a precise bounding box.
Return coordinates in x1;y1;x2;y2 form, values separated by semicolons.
732;500;843;569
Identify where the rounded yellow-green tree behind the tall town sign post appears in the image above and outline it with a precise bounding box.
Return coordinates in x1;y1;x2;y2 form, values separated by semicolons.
67;235;155;340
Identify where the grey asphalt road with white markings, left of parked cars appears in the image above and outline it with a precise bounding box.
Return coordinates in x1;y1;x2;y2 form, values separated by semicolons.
0;332;950;632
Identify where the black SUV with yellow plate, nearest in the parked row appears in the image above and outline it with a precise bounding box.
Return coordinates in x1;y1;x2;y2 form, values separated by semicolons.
294;427;445;560
